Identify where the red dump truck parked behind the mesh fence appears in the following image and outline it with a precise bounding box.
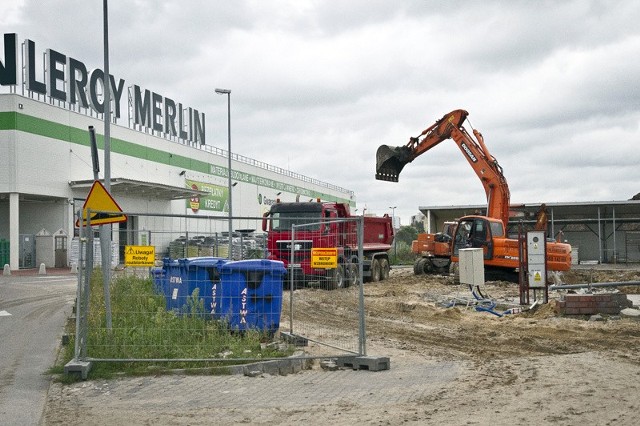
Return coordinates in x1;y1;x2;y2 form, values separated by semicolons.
262;200;393;289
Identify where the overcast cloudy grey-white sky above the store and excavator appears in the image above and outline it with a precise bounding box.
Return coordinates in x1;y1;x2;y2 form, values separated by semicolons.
0;0;640;225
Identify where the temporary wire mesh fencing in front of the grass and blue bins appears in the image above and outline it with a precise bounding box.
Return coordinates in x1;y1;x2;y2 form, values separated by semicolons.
70;212;366;371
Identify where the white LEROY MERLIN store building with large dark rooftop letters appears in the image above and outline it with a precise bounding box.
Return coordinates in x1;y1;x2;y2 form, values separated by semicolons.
0;34;355;270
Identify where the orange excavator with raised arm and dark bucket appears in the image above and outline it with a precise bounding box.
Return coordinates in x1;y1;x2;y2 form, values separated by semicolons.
376;109;571;281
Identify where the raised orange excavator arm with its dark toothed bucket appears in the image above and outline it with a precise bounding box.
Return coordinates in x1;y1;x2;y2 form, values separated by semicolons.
376;109;510;226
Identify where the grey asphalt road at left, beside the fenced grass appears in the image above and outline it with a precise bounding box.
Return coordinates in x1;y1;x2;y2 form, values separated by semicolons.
0;274;77;425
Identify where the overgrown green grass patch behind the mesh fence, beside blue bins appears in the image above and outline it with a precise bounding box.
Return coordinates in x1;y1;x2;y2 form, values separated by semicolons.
58;270;294;379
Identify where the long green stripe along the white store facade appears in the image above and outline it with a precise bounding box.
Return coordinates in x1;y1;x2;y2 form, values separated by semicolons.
0;111;353;205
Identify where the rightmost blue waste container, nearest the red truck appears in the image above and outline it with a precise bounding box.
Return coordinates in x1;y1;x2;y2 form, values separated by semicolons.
219;259;286;334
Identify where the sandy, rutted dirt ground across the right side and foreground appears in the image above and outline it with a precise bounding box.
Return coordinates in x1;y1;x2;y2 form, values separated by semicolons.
44;267;640;425
